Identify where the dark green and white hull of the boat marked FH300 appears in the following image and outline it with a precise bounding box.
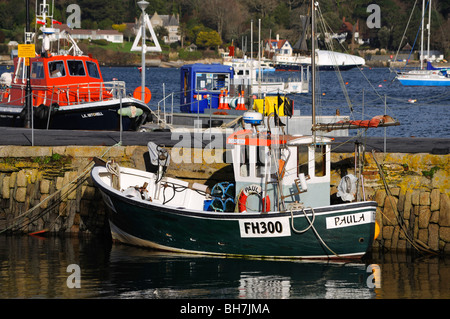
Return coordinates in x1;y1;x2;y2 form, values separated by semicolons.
92;167;376;259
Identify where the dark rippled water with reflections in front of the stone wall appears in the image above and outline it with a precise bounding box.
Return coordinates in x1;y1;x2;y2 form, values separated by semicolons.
0;236;450;299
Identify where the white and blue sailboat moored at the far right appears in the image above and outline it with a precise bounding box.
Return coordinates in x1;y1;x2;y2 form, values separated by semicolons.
396;0;450;86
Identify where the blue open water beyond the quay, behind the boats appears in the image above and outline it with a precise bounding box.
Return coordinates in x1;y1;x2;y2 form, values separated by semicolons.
98;67;450;137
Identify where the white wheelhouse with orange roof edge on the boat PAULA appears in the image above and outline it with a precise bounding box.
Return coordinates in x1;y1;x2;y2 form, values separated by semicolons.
227;112;331;212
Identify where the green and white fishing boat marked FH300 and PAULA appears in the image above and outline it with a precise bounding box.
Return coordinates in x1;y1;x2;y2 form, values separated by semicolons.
91;6;384;259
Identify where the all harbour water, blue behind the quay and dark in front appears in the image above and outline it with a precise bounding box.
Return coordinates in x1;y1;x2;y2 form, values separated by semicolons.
0;67;450;300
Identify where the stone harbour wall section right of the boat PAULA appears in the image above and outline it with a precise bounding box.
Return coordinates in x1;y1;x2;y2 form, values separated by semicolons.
332;153;450;253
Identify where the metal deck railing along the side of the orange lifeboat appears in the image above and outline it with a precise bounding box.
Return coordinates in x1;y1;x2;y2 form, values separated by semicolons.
8;81;126;106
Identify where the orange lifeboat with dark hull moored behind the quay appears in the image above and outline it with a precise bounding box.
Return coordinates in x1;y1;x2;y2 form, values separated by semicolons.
0;0;151;130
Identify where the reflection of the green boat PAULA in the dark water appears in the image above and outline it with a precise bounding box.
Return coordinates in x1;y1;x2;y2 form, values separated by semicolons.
110;245;376;299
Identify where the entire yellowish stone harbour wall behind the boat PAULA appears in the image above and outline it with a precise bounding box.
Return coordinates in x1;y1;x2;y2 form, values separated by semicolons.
0;146;450;253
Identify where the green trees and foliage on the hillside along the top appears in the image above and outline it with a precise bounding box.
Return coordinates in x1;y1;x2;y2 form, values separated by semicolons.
0;0;450;57
